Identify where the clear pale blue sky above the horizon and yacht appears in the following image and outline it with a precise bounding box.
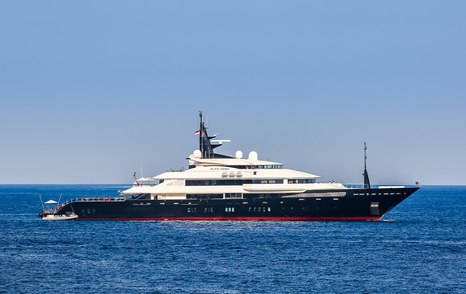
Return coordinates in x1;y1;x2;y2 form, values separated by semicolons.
0;0;466;184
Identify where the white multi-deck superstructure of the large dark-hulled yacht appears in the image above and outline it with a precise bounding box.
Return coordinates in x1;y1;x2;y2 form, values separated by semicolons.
122;150;345;200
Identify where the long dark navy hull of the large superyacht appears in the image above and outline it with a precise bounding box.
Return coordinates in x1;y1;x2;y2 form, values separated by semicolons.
57;187;419;221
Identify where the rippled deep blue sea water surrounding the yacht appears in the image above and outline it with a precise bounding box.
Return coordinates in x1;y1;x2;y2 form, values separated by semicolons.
0;185;466;293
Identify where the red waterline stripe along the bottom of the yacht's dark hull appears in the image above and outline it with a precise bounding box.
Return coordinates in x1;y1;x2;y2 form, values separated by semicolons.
78;216;381;221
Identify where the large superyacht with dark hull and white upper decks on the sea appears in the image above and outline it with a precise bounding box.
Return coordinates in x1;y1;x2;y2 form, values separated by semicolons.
40;113;419;221
